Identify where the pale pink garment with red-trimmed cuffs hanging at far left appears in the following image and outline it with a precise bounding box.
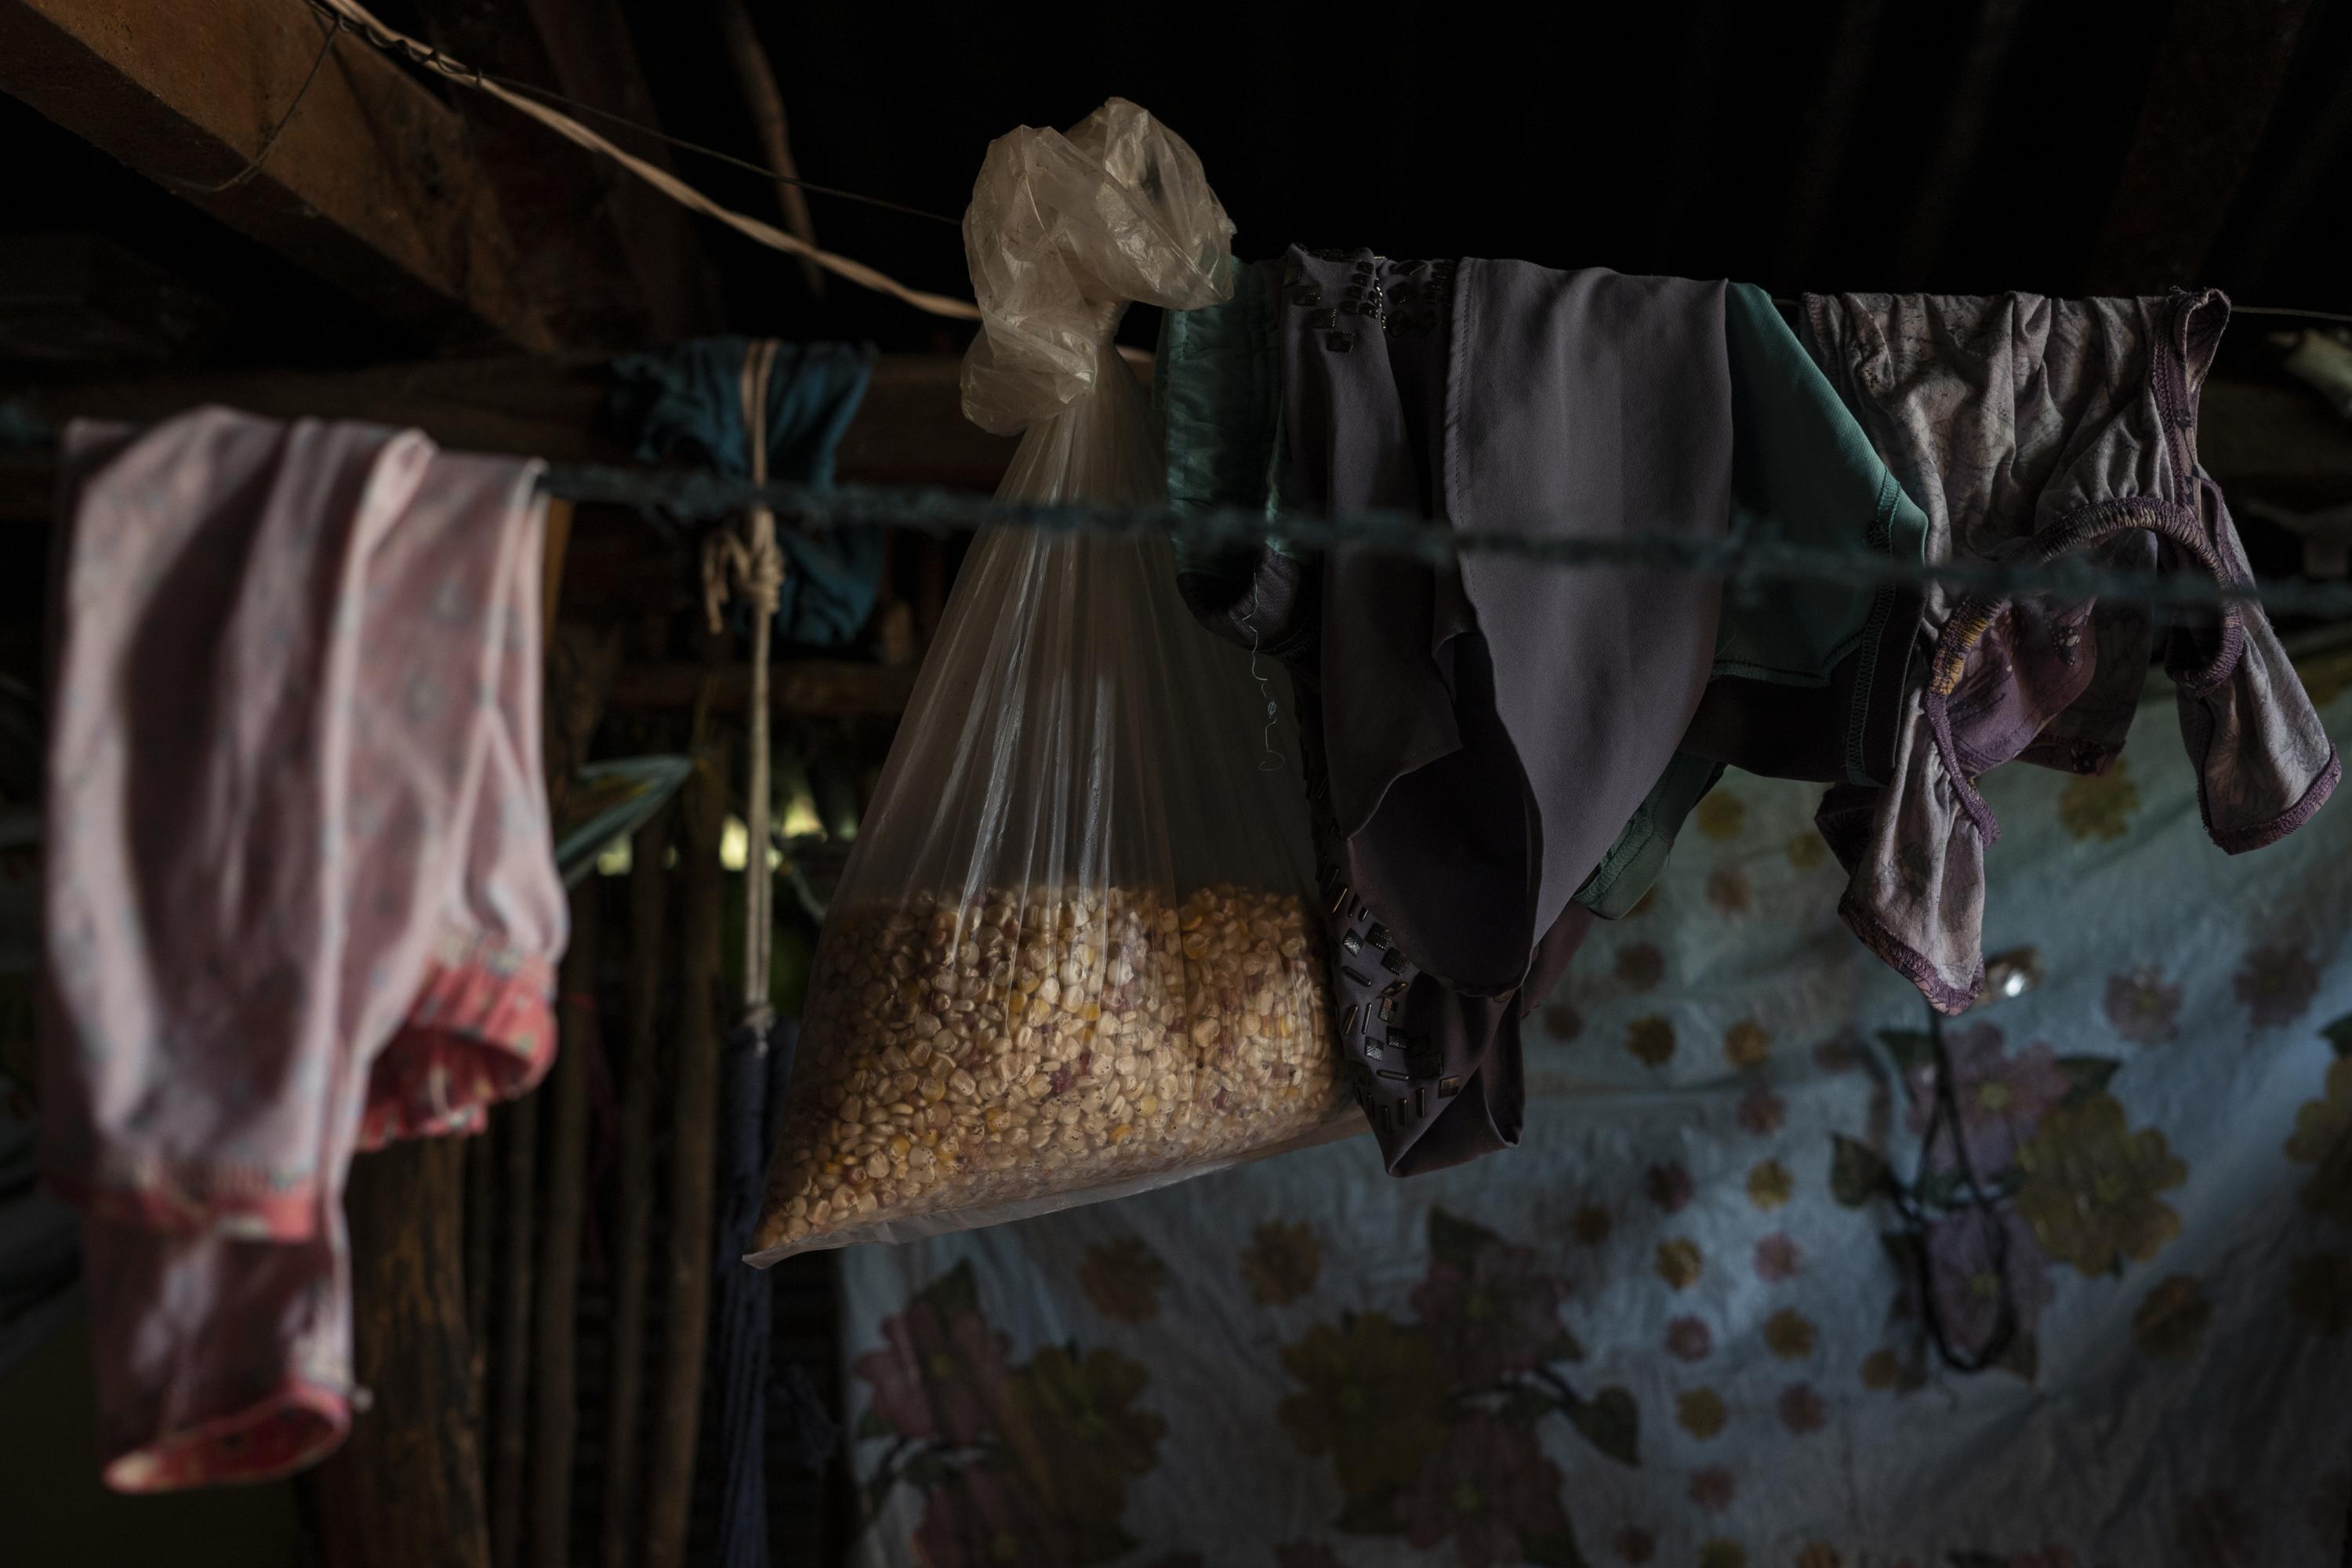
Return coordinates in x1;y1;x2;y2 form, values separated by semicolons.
42;409;564;1490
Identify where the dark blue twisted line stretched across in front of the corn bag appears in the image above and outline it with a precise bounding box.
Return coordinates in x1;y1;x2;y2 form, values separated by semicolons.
541;463;2352;619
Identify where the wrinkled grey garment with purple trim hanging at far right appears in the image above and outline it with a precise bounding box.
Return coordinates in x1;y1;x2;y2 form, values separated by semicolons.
1804;292;2343;1013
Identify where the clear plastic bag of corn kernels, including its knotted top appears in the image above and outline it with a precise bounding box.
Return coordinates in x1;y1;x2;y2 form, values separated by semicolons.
750;99;1352;1265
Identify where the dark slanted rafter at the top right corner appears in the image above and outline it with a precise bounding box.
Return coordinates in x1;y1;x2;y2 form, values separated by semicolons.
2086;0;2312;294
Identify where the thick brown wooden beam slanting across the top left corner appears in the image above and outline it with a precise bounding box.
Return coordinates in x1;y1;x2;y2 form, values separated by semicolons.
0;0;555;350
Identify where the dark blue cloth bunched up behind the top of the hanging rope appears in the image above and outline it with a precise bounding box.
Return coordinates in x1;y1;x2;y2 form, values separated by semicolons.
612;336;882;647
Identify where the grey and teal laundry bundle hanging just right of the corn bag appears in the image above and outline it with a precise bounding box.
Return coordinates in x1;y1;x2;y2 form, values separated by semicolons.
1155;252;1926;1173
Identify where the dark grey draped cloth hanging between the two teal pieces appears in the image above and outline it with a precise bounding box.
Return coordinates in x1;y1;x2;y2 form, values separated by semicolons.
1282;249;1731;1175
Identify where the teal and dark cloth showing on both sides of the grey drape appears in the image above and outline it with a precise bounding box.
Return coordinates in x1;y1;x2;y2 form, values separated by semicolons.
1152;276;1926;919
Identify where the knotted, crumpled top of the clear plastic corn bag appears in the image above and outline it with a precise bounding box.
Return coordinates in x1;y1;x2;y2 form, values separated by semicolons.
964;99;1232;435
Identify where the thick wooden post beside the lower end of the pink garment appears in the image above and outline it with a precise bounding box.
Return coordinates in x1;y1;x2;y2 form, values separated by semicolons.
303;1138;489;1568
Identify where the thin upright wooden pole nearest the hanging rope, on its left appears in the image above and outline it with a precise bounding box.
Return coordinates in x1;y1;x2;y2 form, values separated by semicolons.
642;746;727;1568
